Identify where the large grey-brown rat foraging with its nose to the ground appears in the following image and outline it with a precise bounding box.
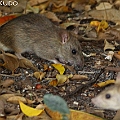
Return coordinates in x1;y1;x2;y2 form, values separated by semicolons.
0;13;84;69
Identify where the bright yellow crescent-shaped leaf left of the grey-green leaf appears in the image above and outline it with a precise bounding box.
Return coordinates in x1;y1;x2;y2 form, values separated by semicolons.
19;101;43;117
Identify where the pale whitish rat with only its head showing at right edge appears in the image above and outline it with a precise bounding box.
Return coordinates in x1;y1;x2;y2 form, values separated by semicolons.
92;72;120;110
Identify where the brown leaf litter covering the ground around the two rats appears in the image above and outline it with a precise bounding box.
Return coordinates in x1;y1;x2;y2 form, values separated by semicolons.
0;0;120;120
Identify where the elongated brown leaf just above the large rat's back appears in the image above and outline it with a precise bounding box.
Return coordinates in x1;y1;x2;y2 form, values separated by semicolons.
44;11;62;23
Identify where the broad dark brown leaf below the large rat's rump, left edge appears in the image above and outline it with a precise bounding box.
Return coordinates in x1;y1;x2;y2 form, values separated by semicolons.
2;52;19;74
